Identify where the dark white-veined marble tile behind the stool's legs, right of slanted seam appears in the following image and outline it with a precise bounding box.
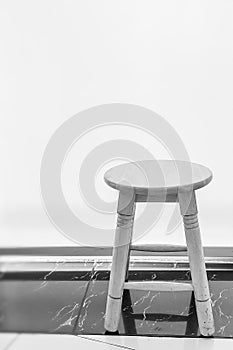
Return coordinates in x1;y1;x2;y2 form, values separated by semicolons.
75;271;233;338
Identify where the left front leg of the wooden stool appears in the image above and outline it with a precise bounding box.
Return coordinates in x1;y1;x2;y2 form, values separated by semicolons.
104;191;135;332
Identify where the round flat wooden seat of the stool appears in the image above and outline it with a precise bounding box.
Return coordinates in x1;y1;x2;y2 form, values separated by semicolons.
104;160;212;195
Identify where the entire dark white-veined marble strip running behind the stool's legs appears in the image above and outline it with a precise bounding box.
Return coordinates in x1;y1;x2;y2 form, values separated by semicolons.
0;269;233;338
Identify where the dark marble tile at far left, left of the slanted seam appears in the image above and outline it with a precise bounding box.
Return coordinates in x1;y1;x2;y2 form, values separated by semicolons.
0;280;87;333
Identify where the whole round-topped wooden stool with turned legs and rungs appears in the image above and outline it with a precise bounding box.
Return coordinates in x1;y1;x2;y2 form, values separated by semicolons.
104;160;214;336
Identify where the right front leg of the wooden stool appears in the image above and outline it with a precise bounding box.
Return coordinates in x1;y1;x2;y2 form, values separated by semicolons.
178;191;214;337
